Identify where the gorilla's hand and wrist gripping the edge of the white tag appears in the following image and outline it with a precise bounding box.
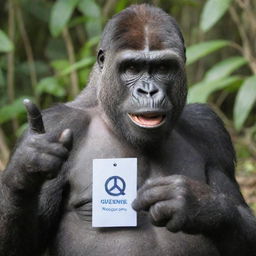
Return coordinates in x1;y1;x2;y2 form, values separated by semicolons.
132;175;237;233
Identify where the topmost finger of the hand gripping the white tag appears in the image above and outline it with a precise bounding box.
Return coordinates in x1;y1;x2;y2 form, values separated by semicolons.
132;186;172;211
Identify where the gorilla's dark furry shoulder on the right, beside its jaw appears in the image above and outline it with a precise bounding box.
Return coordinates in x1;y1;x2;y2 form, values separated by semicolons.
176;103;236;172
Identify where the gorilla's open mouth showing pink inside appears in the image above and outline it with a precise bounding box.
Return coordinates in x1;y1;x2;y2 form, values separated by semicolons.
128;113;165;128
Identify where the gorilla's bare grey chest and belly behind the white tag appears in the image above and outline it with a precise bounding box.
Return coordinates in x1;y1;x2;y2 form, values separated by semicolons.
53;120;212;256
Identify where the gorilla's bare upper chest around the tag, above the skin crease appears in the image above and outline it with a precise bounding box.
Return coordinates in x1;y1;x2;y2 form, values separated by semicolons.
69;119;206;201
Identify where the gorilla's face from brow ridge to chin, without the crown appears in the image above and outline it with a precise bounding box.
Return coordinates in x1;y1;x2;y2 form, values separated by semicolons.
98;49;186;146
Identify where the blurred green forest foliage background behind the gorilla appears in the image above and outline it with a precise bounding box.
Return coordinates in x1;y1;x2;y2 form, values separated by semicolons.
0;0;256;211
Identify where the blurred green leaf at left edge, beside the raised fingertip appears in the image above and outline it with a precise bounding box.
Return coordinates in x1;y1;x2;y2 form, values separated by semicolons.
0;97;29;124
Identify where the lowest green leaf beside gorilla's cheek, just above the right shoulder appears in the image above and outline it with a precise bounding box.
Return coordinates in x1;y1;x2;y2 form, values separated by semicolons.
188;76;243;103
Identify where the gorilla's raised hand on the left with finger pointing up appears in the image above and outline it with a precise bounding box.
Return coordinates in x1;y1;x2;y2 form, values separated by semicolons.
5;100;72;190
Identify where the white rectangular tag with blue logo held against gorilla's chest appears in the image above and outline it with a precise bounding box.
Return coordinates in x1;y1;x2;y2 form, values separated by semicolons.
92;158;137;227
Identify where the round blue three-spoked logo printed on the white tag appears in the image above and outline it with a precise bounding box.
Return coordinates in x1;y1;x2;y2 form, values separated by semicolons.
105;176;126;196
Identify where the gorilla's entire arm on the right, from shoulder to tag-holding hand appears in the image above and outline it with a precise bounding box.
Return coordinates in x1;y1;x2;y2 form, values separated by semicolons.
133;104;256;256
